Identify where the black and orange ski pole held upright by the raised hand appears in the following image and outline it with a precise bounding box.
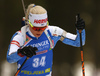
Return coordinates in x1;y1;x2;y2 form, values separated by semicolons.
76;14;85;76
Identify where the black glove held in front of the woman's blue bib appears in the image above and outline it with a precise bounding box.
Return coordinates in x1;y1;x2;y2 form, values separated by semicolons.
17;46;38;58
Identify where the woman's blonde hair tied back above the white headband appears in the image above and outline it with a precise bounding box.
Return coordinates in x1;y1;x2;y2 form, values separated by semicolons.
25;4;47;20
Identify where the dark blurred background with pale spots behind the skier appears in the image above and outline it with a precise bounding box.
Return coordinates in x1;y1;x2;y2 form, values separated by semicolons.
0;0;100;76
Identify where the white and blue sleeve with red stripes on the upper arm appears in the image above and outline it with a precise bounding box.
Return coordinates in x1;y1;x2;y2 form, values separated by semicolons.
7;32;23;63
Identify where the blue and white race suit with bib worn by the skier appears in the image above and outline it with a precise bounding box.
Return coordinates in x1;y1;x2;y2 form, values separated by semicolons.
7;26;85;76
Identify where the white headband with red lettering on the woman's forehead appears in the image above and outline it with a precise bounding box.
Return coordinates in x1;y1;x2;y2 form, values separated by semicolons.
29;13;47;27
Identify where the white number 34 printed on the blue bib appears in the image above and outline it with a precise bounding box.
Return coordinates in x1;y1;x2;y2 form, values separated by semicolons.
32;56;46;68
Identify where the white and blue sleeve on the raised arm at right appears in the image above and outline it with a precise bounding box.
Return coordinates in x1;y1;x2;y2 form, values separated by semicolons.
49;26;85;47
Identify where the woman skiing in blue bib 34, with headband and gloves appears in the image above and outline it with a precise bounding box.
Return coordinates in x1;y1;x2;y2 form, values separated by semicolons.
7;4;85;76
